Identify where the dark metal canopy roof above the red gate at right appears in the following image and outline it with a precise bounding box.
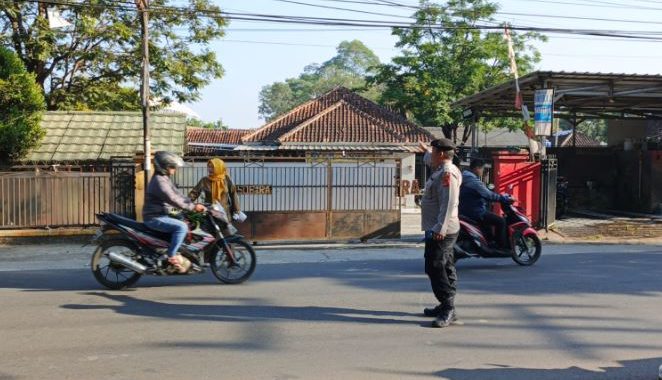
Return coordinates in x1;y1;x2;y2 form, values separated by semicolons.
453;71;662;119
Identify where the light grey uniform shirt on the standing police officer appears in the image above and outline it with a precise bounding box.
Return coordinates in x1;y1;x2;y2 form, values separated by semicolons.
421;161;462;235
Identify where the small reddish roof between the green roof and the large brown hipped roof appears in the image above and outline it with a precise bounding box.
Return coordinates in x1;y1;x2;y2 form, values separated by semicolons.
186;127;254;155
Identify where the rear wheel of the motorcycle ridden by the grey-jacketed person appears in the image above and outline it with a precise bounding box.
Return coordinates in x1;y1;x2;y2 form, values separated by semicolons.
90;239;142;290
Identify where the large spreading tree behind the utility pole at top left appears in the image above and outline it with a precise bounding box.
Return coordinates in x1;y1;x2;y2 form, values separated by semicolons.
0;0;225;110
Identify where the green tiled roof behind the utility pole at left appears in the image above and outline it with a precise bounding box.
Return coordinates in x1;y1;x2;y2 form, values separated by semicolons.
24;111;186;162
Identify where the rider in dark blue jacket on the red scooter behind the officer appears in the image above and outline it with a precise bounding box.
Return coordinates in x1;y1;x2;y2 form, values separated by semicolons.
460;158;510;249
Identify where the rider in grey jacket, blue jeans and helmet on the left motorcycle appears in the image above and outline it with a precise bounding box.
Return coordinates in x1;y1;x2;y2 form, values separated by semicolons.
143;151;207;272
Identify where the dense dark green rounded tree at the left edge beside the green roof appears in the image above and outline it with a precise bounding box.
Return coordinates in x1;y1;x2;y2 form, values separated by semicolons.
0;46;45;162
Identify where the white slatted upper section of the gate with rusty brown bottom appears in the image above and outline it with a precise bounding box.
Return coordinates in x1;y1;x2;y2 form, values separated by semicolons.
175;162;399;212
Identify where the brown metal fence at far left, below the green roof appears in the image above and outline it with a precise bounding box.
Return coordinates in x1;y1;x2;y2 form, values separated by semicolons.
0;172;110;229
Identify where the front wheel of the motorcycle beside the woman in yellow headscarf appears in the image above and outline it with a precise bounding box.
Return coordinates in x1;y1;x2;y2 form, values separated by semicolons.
209;240;257;284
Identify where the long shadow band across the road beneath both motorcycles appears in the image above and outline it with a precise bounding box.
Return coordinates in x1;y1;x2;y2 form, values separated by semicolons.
0;247;662;296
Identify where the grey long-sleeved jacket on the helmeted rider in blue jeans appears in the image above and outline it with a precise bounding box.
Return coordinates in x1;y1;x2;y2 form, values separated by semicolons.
143;174;195;221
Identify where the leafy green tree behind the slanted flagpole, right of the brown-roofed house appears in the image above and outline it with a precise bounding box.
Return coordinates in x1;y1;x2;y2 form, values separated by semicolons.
369;0;544;126
